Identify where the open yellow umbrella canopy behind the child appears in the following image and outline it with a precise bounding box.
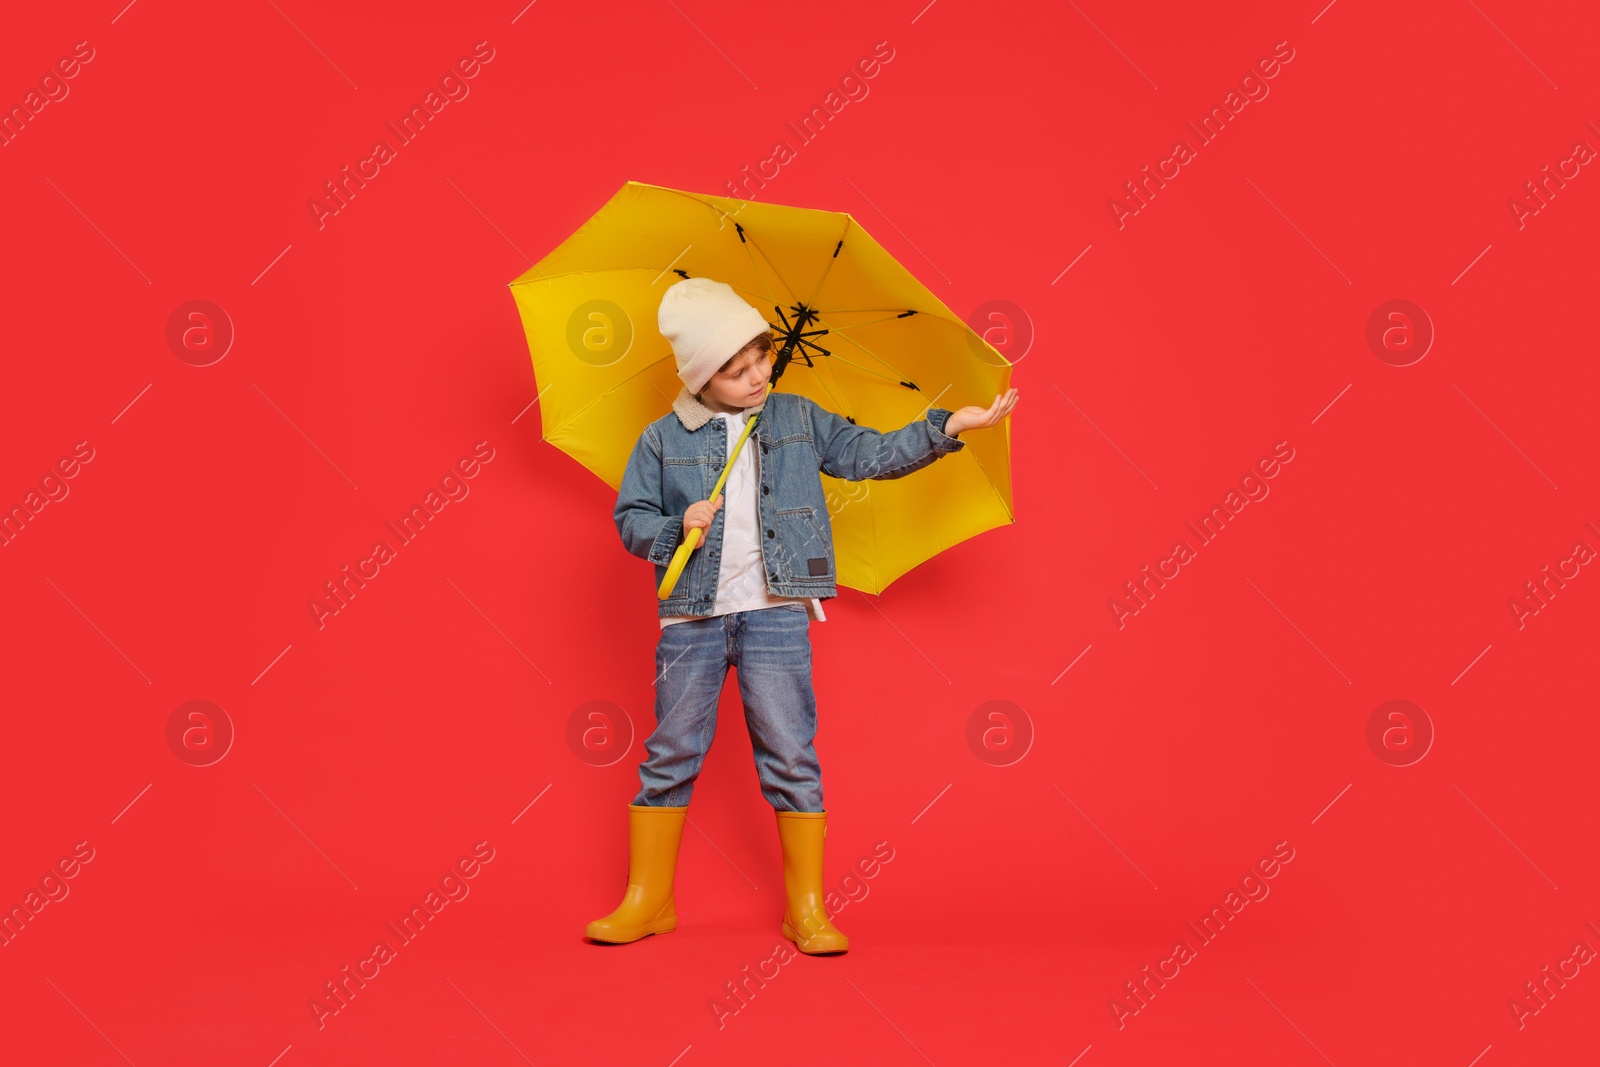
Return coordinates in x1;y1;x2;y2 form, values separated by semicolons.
510;181;1013;593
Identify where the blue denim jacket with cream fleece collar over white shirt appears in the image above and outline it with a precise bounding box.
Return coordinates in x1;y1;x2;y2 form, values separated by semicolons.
613;389;966;617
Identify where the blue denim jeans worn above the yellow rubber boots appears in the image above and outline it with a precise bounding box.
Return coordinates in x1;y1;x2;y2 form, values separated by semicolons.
634;605;822;811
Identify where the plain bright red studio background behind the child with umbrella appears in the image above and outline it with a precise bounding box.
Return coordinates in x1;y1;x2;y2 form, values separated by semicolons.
0;0;1600;1067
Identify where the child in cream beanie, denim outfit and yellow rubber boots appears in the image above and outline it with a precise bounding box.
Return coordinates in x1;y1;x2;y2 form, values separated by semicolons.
586;278;1016;955
